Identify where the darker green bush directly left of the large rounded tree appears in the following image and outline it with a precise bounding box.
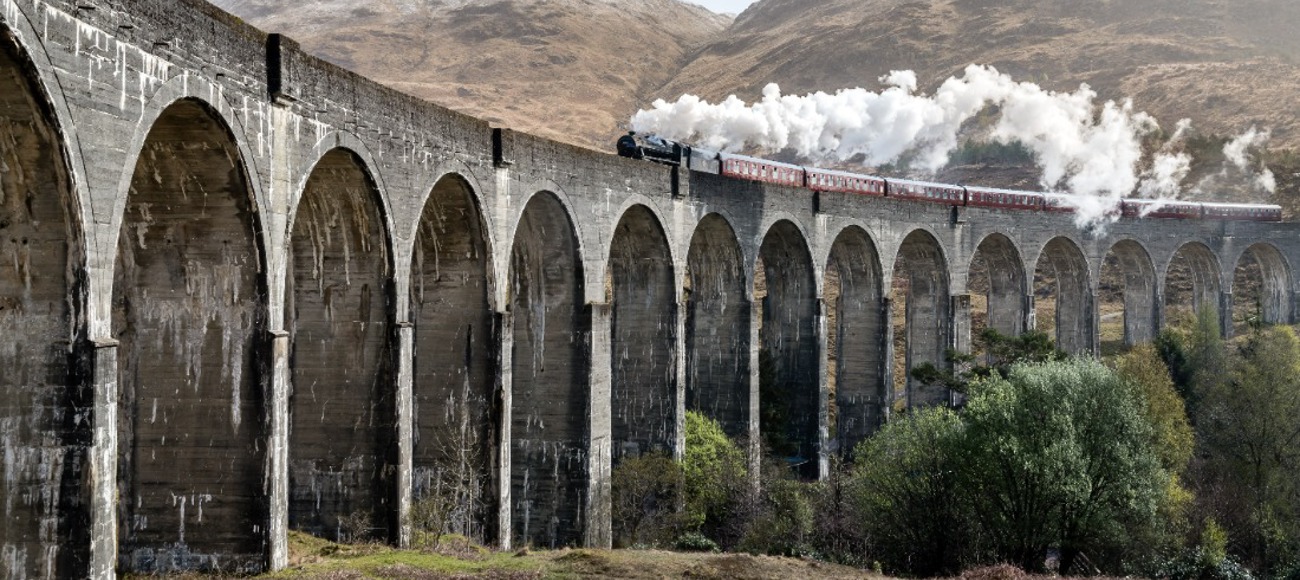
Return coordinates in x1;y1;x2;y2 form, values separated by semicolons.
850;407;975;576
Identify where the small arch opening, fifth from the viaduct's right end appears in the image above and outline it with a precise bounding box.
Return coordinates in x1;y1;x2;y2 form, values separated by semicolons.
966;234;1028;337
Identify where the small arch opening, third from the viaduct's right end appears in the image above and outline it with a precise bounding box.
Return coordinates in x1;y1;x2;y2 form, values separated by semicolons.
1097;239;1157;354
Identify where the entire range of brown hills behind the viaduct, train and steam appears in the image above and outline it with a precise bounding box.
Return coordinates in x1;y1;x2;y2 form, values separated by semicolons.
210;0;1300;204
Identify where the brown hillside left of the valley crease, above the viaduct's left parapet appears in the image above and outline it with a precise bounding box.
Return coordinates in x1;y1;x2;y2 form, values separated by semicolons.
216;0;731;150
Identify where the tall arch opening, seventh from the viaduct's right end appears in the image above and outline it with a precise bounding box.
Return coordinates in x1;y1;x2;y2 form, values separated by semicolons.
823;228;889;459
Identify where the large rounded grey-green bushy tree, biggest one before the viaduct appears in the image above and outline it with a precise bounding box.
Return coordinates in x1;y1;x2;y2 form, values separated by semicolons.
965;360;1169;572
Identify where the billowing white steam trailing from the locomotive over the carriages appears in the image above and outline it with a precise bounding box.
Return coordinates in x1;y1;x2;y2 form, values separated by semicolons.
632;65;1271;225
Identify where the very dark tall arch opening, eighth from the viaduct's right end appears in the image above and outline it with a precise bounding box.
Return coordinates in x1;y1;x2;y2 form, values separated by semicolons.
754;220;823;477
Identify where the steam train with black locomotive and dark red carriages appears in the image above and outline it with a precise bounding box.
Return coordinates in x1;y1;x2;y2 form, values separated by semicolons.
615;133;1282;221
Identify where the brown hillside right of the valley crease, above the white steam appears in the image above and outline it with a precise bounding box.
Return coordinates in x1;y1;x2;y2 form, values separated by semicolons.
655;0;1300;151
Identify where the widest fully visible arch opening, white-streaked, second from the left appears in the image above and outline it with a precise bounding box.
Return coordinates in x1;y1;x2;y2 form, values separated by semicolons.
113;100;267;572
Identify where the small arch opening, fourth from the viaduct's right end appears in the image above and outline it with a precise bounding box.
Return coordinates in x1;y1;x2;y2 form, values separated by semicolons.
1034;237;1093;354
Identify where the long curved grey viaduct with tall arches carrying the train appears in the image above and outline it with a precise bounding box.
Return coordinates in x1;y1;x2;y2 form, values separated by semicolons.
0;0;1300;577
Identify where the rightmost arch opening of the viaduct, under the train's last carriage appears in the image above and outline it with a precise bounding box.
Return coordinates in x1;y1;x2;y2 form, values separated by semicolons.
1232;243;1291;333
